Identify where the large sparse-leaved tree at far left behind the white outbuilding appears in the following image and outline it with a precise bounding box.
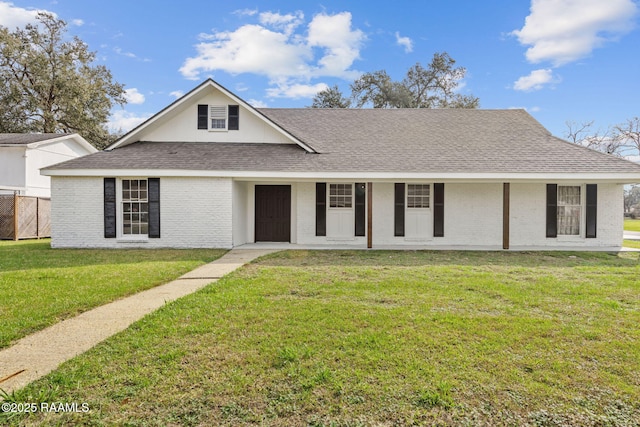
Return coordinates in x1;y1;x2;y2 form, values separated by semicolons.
0;13;126;148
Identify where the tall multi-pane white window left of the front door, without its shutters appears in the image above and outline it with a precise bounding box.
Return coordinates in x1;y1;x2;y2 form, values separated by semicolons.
122;179;149;235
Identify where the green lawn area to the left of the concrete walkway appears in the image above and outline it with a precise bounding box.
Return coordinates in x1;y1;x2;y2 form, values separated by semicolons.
0;240;224;348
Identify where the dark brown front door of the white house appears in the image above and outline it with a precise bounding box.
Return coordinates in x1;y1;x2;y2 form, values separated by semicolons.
256;185;291;242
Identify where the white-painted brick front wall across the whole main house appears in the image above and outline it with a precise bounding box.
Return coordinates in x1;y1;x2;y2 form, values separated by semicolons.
51;177;623;249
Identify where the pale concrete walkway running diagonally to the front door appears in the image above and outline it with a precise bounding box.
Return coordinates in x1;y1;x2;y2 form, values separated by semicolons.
0;249;276;393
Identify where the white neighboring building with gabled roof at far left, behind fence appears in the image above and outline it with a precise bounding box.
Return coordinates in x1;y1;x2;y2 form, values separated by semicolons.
0;133;98;197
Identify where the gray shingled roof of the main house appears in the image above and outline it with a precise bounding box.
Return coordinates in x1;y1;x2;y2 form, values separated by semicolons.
42;109;640;174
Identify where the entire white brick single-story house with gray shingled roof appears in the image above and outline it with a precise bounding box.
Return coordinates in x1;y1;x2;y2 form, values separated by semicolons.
43;80;640;250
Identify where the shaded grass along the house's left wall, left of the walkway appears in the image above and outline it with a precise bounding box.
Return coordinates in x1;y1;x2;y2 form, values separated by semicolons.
0;239;226;273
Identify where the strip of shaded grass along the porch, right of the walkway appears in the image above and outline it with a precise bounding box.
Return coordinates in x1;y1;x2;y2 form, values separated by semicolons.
256;250;640;268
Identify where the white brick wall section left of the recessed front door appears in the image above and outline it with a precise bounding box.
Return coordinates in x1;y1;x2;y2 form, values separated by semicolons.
51;177;232;248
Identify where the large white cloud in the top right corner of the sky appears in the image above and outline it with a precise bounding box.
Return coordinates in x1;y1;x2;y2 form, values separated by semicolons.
511;0;638;66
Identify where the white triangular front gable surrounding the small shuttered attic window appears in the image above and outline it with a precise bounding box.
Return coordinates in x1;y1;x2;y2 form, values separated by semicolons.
107;79;314;152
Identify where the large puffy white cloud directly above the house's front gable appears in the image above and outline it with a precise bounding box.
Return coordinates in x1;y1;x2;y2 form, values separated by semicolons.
180;12;365;97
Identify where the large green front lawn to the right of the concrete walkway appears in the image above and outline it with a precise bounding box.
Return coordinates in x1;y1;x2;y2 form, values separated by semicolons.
7;251;640;426
